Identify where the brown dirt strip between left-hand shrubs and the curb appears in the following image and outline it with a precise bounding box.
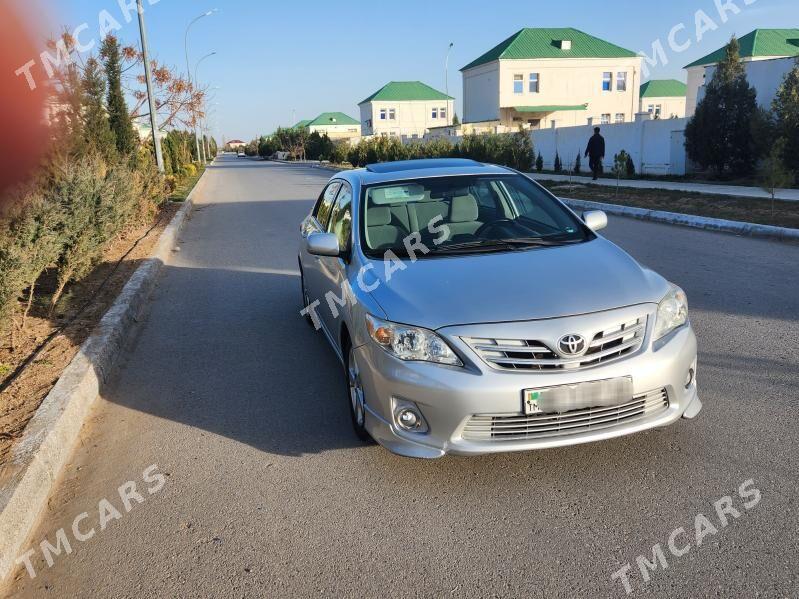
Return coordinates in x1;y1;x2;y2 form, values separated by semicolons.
0;203;180;466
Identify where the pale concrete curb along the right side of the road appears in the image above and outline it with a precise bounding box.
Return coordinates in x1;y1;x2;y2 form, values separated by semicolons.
560;198;799;241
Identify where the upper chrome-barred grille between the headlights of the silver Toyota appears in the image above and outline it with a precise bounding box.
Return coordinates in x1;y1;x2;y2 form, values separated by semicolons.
464;316;646;370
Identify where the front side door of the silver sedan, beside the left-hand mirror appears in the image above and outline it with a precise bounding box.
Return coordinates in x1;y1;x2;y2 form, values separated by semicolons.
319;181;352;343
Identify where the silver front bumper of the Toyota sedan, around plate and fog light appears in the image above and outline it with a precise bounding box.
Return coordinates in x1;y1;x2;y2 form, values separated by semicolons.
355;308;702;458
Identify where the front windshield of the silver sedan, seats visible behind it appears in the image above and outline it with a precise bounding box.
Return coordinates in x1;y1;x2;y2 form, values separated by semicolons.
361;174;593;256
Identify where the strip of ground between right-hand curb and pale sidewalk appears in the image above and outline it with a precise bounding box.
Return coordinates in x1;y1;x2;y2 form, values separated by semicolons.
539;181;799;229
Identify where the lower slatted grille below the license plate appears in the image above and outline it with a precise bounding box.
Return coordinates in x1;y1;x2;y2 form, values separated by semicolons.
463;389;669;441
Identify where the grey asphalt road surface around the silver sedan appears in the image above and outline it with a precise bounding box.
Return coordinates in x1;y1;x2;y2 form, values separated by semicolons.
10;158;799;597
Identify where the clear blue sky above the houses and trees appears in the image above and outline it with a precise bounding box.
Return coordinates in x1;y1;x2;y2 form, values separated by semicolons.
48;0;799;140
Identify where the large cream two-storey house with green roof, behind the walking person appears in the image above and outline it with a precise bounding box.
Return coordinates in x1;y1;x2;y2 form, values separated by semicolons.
461;27;642;131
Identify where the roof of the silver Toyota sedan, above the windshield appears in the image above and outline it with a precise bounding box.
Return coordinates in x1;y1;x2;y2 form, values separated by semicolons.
336;158;514;185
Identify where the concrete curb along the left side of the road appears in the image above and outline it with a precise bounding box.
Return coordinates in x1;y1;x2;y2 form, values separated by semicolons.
0;168;207;583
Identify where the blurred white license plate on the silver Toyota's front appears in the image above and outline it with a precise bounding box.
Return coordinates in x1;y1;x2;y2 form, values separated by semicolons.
522;376;633;415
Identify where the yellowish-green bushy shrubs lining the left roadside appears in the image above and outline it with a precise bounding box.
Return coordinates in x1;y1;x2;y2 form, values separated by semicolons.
0;154;165;338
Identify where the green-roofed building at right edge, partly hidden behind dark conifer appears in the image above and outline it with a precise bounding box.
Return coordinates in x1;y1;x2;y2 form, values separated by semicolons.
685;29;799;117
